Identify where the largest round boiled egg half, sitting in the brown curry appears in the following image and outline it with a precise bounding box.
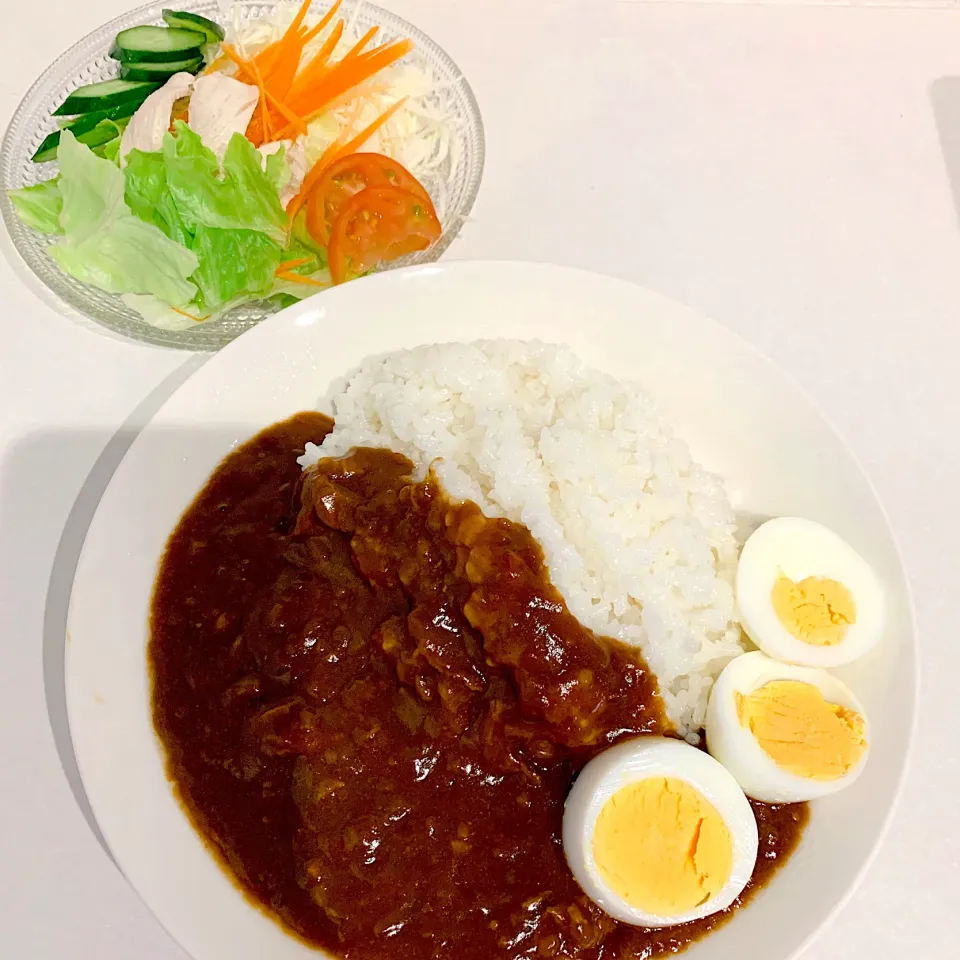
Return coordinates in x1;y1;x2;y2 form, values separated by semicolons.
563;737;757;927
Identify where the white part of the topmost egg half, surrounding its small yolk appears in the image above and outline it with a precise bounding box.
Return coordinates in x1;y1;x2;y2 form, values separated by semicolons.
737;517;886;667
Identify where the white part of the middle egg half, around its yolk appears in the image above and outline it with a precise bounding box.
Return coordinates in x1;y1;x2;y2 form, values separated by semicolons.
706;652;870;803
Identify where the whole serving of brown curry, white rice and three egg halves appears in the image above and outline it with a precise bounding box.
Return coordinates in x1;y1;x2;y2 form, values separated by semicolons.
149;341;883;960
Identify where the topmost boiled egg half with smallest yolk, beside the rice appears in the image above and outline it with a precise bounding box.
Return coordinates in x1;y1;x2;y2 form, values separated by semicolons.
737;517;885;667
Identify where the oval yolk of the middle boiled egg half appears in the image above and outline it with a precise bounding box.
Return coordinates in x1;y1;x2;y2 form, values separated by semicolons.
736;680;867;780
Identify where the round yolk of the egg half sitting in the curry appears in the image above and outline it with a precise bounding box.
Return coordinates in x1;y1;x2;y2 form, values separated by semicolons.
593;777;733;917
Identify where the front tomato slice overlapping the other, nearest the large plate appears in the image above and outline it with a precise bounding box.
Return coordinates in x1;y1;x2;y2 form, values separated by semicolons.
327;187;443;283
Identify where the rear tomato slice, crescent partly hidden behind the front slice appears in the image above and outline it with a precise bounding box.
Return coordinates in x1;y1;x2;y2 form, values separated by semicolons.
307;153;436;245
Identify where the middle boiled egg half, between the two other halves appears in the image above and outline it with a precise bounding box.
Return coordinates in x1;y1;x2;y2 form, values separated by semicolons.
706;652;869;803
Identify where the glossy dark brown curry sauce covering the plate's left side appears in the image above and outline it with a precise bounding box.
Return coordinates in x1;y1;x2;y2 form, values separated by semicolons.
149;414;807;960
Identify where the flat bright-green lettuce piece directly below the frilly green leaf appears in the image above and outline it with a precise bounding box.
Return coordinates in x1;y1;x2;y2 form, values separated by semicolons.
191;224;283;313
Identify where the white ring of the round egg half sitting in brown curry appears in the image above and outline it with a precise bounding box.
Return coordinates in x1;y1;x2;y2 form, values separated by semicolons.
563;737;758;927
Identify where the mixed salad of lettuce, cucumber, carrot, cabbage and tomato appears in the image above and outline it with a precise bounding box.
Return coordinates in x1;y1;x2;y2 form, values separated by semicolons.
3;0;460;329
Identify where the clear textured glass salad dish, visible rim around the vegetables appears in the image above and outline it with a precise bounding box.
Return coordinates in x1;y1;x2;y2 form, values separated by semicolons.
0;0;484;351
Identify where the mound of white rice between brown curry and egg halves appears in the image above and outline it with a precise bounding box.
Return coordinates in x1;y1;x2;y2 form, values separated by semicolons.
300;340;743;742
